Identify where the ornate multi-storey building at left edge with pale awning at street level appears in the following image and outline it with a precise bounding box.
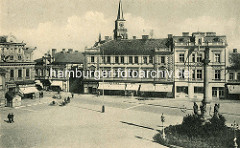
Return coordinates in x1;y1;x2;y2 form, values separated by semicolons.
0;35;37;97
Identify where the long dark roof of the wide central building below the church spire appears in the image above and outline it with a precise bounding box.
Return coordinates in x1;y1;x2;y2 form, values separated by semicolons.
97;38;168;55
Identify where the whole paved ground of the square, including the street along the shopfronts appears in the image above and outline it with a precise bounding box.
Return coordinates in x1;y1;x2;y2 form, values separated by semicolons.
0;92;240;147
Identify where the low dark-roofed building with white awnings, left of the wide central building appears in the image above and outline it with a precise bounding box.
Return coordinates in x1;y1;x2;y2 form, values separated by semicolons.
35;49;84;92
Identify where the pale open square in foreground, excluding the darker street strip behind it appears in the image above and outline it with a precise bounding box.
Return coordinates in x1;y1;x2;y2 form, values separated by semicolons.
0;93;168;148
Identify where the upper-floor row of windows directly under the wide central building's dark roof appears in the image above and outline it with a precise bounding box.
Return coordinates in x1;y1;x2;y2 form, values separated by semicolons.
91;56;159;64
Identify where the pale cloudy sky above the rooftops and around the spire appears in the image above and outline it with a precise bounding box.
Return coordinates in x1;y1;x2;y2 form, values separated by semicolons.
0;0;240;58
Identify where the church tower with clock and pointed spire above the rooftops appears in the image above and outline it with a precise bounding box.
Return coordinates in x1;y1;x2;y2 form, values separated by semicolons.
113;0;128;40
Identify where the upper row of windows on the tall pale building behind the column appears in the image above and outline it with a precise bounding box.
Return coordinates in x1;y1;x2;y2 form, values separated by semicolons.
179;53;221;63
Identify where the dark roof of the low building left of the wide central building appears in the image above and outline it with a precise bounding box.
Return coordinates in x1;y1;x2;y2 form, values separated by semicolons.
53;52;84;64
